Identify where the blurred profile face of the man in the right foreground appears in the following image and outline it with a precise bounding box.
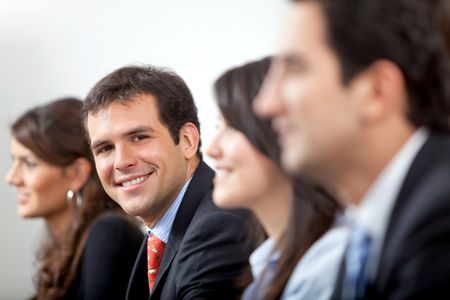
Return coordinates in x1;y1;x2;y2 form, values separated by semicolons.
255;2;361;177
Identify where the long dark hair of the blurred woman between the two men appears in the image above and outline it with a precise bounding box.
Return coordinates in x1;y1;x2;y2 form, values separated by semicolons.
214;57;339;299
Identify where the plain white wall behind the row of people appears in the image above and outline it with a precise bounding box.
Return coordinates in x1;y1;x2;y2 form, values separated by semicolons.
0;0;286;300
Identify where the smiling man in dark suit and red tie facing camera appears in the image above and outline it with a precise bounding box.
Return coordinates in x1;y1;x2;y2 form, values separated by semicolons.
83;66;251;300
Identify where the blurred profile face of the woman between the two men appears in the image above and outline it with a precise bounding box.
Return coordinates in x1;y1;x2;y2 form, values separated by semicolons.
206;117;287;209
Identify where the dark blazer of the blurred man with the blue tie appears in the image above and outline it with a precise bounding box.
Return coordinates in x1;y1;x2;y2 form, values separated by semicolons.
334;133;450;299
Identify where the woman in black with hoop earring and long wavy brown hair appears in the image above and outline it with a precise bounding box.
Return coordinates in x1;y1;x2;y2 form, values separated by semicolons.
6;98;143;300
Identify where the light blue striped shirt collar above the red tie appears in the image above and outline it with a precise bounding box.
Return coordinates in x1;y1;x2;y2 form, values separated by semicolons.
147;177;192;244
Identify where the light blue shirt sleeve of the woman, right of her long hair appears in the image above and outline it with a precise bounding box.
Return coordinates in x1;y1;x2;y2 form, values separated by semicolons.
281;215;350;300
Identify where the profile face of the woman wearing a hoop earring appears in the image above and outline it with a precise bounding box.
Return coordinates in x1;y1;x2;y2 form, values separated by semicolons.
6;137;70;219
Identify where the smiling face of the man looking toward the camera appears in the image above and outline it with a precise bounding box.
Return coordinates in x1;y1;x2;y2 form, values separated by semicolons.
87;95;188;225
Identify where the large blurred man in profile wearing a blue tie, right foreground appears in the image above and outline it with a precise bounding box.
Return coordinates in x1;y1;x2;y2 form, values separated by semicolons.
255;0;450;299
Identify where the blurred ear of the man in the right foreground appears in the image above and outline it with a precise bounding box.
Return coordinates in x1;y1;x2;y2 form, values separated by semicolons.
356;59;408;123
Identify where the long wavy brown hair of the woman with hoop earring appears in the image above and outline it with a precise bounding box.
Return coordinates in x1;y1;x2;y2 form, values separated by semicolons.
11;98;120;300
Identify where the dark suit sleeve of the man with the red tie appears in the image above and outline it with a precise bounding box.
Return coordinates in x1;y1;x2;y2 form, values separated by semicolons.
173;197;251;299
